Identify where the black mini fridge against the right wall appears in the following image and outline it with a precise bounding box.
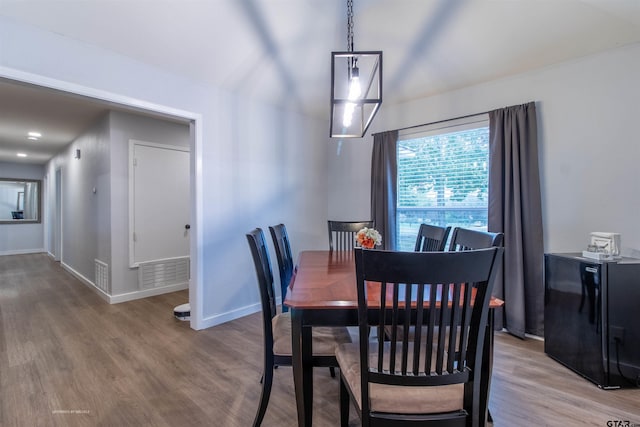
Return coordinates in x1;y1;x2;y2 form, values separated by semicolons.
544;253;640;388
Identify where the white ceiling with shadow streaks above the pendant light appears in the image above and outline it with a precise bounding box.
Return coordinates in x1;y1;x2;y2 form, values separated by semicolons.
0;0;640;161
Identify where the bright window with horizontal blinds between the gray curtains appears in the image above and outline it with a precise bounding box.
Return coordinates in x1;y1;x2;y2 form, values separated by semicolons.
396;116;489;251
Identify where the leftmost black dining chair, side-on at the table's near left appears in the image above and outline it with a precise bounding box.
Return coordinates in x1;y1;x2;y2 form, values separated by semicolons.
246;228;351;427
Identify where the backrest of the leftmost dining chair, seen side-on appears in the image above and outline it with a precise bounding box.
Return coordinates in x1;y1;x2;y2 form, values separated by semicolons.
247;228;277;332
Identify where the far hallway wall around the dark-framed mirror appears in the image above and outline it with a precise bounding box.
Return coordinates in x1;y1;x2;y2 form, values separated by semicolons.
0;162;45;255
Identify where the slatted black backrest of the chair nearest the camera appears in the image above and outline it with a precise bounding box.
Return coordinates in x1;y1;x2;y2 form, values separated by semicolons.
355;247;504;422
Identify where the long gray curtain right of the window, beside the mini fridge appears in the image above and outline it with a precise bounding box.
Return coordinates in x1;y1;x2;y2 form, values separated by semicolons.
488;102;544;338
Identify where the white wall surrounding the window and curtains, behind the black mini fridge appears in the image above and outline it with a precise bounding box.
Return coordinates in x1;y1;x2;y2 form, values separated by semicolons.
328;44;640;256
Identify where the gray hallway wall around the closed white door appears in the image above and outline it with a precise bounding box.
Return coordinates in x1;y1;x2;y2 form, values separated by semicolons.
47;112;189;296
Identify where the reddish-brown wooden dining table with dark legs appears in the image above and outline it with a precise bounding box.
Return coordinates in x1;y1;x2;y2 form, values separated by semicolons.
284;251;504;426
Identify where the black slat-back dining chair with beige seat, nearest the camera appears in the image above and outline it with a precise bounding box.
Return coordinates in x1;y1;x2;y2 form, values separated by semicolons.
336;247;503;427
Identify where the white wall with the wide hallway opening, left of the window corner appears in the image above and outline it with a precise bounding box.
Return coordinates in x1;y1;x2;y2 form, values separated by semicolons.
0;17;328;328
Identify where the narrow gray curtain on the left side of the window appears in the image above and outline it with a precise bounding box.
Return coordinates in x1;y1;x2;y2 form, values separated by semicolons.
371;130;398;249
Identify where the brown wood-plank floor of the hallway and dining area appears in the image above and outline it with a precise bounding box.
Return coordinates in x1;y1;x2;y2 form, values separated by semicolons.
0;254;640;427
